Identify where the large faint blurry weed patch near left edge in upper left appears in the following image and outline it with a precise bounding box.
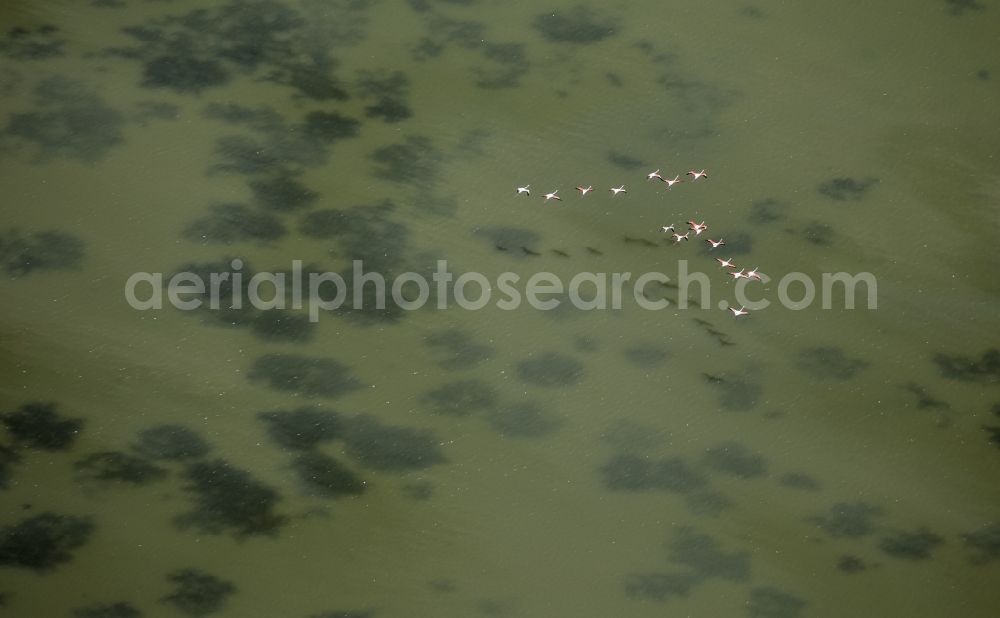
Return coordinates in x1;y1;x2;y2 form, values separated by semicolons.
0;75;127;163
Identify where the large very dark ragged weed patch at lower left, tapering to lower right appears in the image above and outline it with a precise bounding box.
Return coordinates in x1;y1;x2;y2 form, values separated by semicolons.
176;459;287;538
